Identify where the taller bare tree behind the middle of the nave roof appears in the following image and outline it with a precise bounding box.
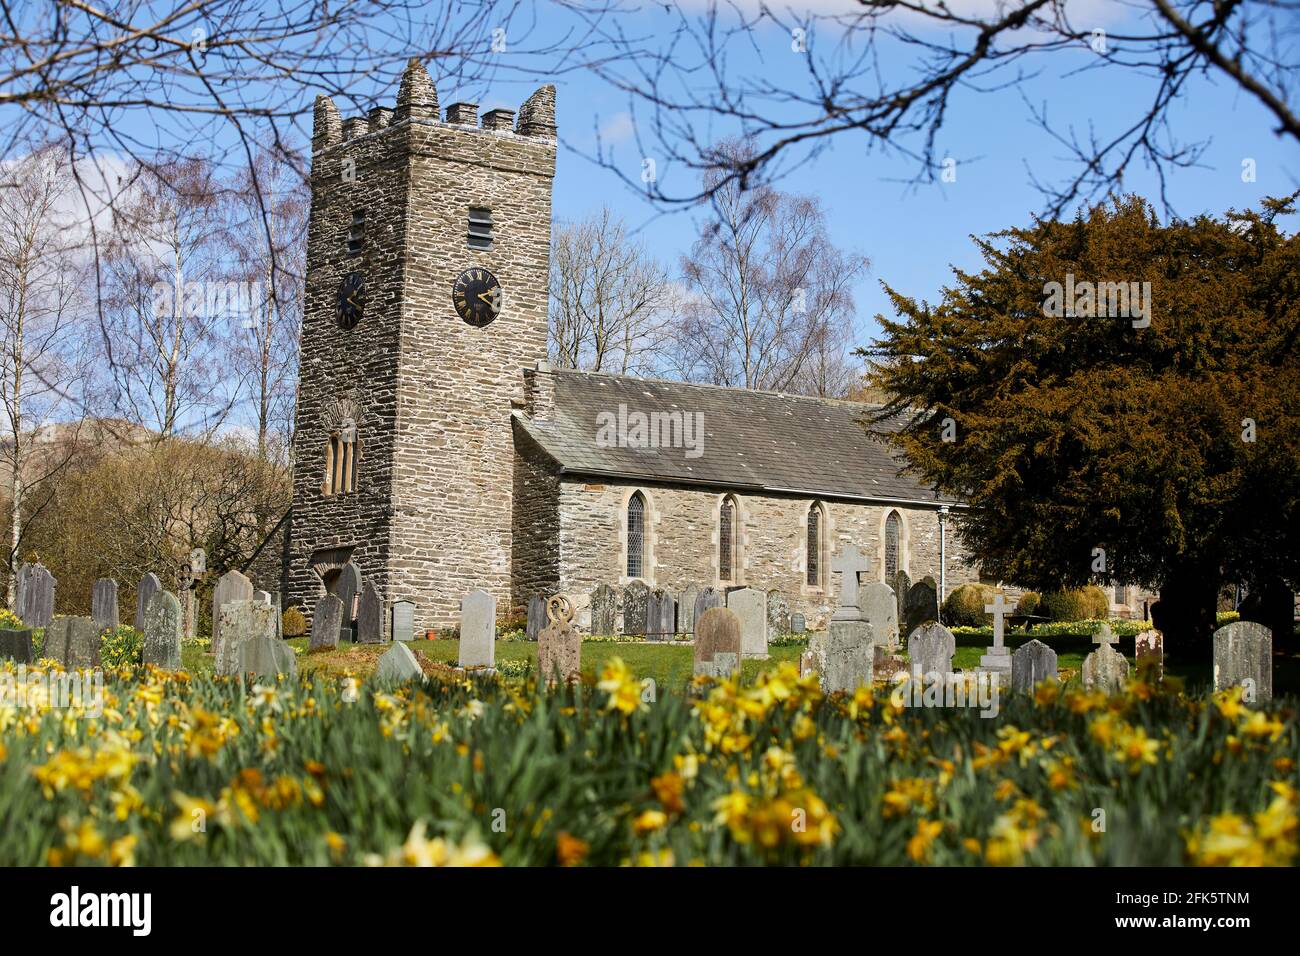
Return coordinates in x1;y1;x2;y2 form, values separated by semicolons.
677;142;868;394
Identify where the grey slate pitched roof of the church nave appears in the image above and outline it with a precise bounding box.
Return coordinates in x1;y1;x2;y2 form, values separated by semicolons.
516;368;958;505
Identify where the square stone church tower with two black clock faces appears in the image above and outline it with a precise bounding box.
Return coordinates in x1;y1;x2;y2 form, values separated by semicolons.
289;61;555;632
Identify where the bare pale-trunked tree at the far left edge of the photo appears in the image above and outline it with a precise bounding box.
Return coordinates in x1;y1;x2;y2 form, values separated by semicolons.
0;146;85;607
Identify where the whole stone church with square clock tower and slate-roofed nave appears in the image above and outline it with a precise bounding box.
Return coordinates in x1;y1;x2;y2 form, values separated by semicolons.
285;55;993;631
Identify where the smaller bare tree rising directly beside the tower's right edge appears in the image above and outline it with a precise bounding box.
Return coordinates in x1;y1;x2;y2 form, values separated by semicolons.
549;207;671;375
